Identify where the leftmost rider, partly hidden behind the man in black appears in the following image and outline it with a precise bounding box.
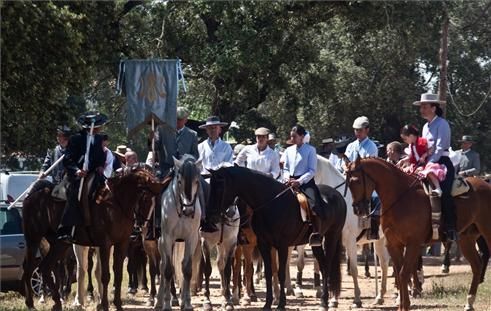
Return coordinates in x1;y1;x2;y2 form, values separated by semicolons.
39;125;72;185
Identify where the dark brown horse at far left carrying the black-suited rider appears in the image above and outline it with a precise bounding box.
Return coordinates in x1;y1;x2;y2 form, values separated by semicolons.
23;167;164;310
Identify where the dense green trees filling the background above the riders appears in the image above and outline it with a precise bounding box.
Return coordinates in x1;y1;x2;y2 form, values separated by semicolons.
0;0;491;171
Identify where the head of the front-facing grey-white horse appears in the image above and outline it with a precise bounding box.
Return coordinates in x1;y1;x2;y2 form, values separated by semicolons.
174;154;201;216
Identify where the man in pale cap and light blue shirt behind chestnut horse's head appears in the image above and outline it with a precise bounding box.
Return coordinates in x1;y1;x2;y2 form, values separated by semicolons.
338;116;380;240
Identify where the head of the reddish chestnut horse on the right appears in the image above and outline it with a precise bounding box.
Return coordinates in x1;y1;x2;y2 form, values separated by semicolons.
345;157;375;216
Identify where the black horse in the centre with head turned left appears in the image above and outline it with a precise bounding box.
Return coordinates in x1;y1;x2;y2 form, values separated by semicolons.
210;167;346;310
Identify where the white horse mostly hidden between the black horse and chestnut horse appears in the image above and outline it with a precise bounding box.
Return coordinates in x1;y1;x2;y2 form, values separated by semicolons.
295;156;390;308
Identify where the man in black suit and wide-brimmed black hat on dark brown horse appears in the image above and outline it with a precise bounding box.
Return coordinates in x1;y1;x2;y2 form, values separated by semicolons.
57;111;107;241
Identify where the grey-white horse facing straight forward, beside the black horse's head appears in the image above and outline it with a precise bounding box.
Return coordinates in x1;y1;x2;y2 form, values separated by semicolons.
155;155;201;310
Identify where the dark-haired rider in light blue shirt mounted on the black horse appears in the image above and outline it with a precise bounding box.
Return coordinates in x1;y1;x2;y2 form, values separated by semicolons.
280;125;323;246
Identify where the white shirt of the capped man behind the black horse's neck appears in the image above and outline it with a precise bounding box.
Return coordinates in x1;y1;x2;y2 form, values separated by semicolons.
235;144;280;178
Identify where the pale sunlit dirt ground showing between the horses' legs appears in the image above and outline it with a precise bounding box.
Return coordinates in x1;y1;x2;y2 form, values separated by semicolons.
120;252;491;310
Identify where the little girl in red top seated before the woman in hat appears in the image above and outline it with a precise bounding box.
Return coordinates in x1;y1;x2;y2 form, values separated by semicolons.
399;125;447;197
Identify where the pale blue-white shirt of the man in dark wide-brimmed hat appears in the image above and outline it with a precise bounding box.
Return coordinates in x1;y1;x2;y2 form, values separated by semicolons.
198;138;234;174
